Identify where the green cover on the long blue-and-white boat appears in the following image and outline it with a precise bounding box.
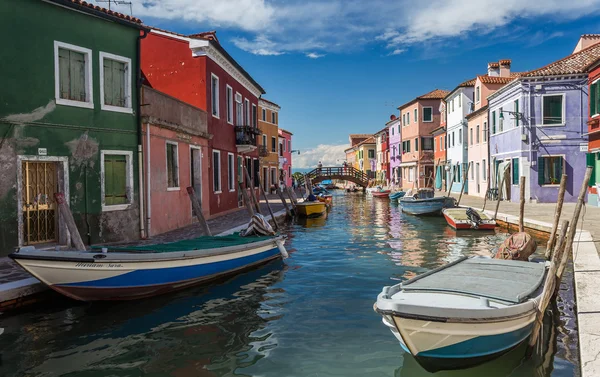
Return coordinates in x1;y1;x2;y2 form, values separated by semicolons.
92;233;273;253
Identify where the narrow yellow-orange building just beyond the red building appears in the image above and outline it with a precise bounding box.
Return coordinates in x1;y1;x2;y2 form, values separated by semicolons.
258;98;281;191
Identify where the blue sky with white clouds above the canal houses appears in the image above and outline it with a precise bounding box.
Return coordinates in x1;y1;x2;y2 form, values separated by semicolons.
94;0;600;167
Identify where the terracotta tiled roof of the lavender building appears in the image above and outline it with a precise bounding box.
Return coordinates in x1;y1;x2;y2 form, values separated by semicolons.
523;43;600;77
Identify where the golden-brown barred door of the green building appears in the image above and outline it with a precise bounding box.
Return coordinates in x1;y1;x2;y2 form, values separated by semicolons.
21;161;58;245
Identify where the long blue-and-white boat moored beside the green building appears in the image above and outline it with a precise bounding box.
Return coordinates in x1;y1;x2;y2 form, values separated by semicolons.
10;235;287;301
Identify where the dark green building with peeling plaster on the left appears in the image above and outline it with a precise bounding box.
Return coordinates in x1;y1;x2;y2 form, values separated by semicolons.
0;0;146;256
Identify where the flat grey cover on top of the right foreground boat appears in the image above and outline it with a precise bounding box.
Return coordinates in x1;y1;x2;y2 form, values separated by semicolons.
401;258;545;304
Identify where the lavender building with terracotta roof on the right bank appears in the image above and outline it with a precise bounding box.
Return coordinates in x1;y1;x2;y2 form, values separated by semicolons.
488;37;600;203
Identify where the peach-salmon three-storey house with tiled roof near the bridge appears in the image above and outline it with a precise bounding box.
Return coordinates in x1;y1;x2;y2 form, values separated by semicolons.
398;89;448;189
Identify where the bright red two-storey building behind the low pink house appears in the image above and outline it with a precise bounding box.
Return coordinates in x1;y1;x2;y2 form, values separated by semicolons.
141;29;265;215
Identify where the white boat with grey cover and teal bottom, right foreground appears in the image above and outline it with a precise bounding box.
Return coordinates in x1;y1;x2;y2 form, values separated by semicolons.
374;257;546;372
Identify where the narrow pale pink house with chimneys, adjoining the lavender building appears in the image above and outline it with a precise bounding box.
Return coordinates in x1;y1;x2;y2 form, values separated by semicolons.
466;59;521;197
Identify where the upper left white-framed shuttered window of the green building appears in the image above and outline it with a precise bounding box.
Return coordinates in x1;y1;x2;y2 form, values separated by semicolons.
54;41;94;109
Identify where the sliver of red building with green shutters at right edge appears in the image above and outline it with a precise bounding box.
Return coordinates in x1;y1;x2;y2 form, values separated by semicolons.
587;61;600;207
